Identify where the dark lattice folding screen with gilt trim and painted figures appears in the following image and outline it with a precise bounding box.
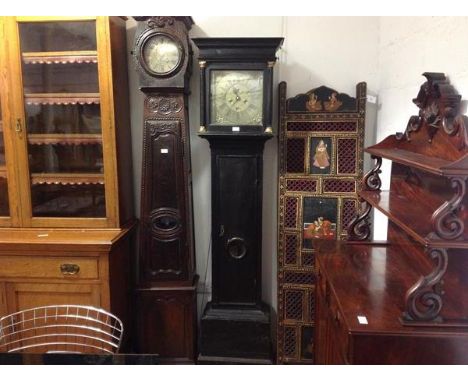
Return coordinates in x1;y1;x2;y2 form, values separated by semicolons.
277;82;366;363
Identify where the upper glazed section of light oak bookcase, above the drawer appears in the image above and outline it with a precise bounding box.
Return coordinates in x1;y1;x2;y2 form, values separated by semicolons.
2;17;131;228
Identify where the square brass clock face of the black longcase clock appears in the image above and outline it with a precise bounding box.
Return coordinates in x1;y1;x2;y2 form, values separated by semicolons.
210;70;263;126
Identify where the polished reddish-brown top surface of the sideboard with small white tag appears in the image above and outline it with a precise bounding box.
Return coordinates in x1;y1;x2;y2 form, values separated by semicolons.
314;240;468;338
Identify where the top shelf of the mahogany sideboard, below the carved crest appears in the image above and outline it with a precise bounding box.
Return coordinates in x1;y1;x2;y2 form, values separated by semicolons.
364;135;468;176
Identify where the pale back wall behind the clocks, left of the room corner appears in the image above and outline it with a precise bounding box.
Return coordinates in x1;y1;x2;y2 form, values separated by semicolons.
127;16;379;311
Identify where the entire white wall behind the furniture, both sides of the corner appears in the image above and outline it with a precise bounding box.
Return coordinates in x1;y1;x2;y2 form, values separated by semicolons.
127;16;468;316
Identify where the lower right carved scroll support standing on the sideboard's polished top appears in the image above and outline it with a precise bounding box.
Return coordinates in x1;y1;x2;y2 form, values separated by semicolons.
402;248;448;325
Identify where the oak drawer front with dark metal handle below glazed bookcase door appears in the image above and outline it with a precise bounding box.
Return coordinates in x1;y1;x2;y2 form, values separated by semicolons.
0;256;99;279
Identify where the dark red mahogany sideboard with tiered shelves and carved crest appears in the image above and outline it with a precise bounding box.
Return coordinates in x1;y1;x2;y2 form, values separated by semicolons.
316;73;468;364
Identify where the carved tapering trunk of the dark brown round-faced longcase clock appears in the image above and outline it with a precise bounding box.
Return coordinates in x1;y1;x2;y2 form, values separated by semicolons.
140;93;194;284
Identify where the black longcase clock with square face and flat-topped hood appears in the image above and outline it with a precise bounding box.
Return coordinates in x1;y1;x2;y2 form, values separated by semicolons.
193;38;283;363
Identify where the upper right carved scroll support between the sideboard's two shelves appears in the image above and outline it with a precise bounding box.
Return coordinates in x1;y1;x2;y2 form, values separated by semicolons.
428;177;468;240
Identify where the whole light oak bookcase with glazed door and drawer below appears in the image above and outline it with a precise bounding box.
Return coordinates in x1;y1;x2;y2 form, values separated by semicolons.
0;16;133;344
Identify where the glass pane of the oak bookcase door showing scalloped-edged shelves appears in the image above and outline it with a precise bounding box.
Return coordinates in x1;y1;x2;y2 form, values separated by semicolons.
18;20;106;218
